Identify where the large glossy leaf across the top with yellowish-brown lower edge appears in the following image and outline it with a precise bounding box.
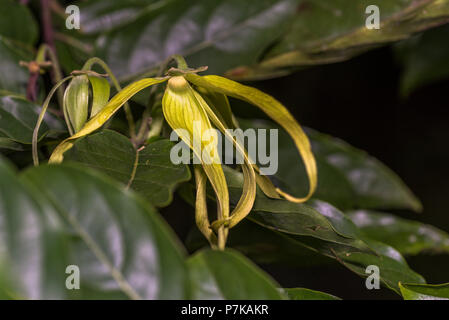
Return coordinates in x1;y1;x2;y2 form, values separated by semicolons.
67;0;449;80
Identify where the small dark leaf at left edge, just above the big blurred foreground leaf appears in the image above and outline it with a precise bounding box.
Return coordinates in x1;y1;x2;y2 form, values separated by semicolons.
0;95;63;146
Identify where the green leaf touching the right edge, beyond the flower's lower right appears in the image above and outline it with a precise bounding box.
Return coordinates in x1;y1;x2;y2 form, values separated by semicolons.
348;210;449;255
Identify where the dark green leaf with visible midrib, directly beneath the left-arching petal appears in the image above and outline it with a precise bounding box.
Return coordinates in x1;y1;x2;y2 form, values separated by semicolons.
64;130;190;207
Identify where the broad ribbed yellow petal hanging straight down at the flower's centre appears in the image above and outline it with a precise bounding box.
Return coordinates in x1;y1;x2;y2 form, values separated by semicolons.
162;76;229;248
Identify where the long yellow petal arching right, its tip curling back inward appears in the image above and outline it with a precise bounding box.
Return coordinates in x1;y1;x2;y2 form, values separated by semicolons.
186;74;318;203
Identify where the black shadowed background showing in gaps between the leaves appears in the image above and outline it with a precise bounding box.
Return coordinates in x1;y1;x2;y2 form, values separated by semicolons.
163;47;449;299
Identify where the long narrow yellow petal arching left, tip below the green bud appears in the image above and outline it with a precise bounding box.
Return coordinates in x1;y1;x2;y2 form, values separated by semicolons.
48;78;167;163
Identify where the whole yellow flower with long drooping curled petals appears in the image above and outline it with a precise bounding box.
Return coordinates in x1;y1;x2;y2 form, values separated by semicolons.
49;57;317;249
